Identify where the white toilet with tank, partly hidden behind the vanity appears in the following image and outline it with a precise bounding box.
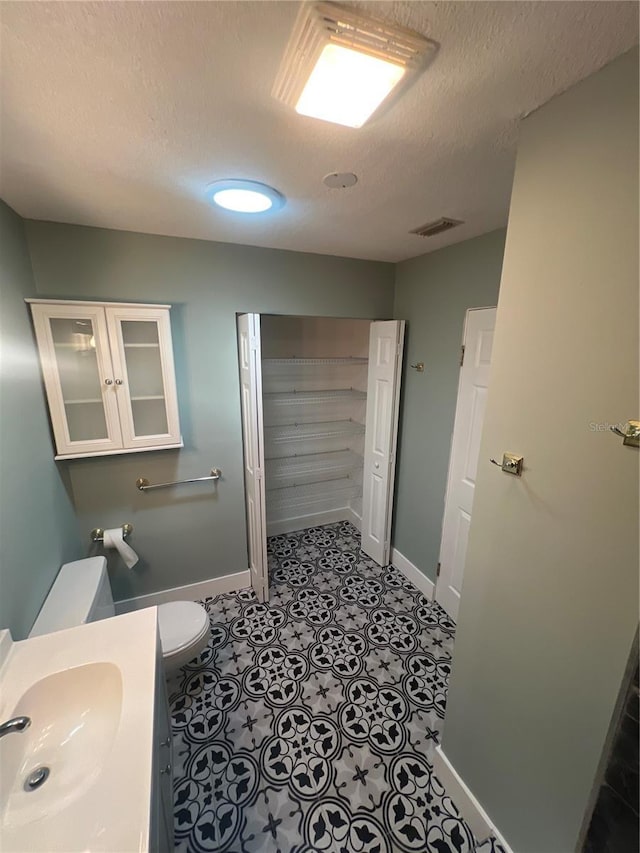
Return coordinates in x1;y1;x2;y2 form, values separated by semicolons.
29;557;209;675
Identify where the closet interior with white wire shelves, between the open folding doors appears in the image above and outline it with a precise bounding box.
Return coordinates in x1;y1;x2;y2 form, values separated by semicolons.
262;340;370;535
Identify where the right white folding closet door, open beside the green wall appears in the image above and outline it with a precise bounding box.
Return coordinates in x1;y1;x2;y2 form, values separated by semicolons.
362;320;404;566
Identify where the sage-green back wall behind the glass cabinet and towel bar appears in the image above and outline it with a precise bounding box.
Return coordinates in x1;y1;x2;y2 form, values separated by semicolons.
26;221;394;599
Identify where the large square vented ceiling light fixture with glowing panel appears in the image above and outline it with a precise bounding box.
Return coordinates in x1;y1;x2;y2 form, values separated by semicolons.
271;3;437;127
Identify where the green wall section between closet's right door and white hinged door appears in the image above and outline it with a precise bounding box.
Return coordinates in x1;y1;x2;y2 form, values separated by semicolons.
393;230;505;581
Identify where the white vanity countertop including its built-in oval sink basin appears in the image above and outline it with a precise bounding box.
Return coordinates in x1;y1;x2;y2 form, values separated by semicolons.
0;607;161;853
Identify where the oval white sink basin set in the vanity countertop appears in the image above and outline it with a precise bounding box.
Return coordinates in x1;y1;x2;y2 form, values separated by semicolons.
0;662;122;829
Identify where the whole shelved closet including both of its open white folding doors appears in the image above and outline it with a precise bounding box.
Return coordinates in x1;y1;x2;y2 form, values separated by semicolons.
238;314;404;599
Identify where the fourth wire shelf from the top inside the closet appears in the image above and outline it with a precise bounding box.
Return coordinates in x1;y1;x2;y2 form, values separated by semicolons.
266;450;362;491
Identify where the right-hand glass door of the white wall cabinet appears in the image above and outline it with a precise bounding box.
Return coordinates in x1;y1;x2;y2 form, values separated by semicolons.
106;307;181;448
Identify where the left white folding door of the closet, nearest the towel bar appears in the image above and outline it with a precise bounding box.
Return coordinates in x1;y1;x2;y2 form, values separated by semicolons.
238;314;269;601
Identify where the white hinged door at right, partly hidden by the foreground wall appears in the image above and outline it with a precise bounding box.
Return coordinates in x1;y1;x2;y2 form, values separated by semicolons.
436;308;496;619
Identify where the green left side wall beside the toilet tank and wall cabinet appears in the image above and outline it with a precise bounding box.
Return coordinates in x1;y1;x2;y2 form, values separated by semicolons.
0;201;79;639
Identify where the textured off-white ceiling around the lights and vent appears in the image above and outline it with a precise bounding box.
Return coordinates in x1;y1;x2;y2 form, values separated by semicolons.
0;0;638;261
